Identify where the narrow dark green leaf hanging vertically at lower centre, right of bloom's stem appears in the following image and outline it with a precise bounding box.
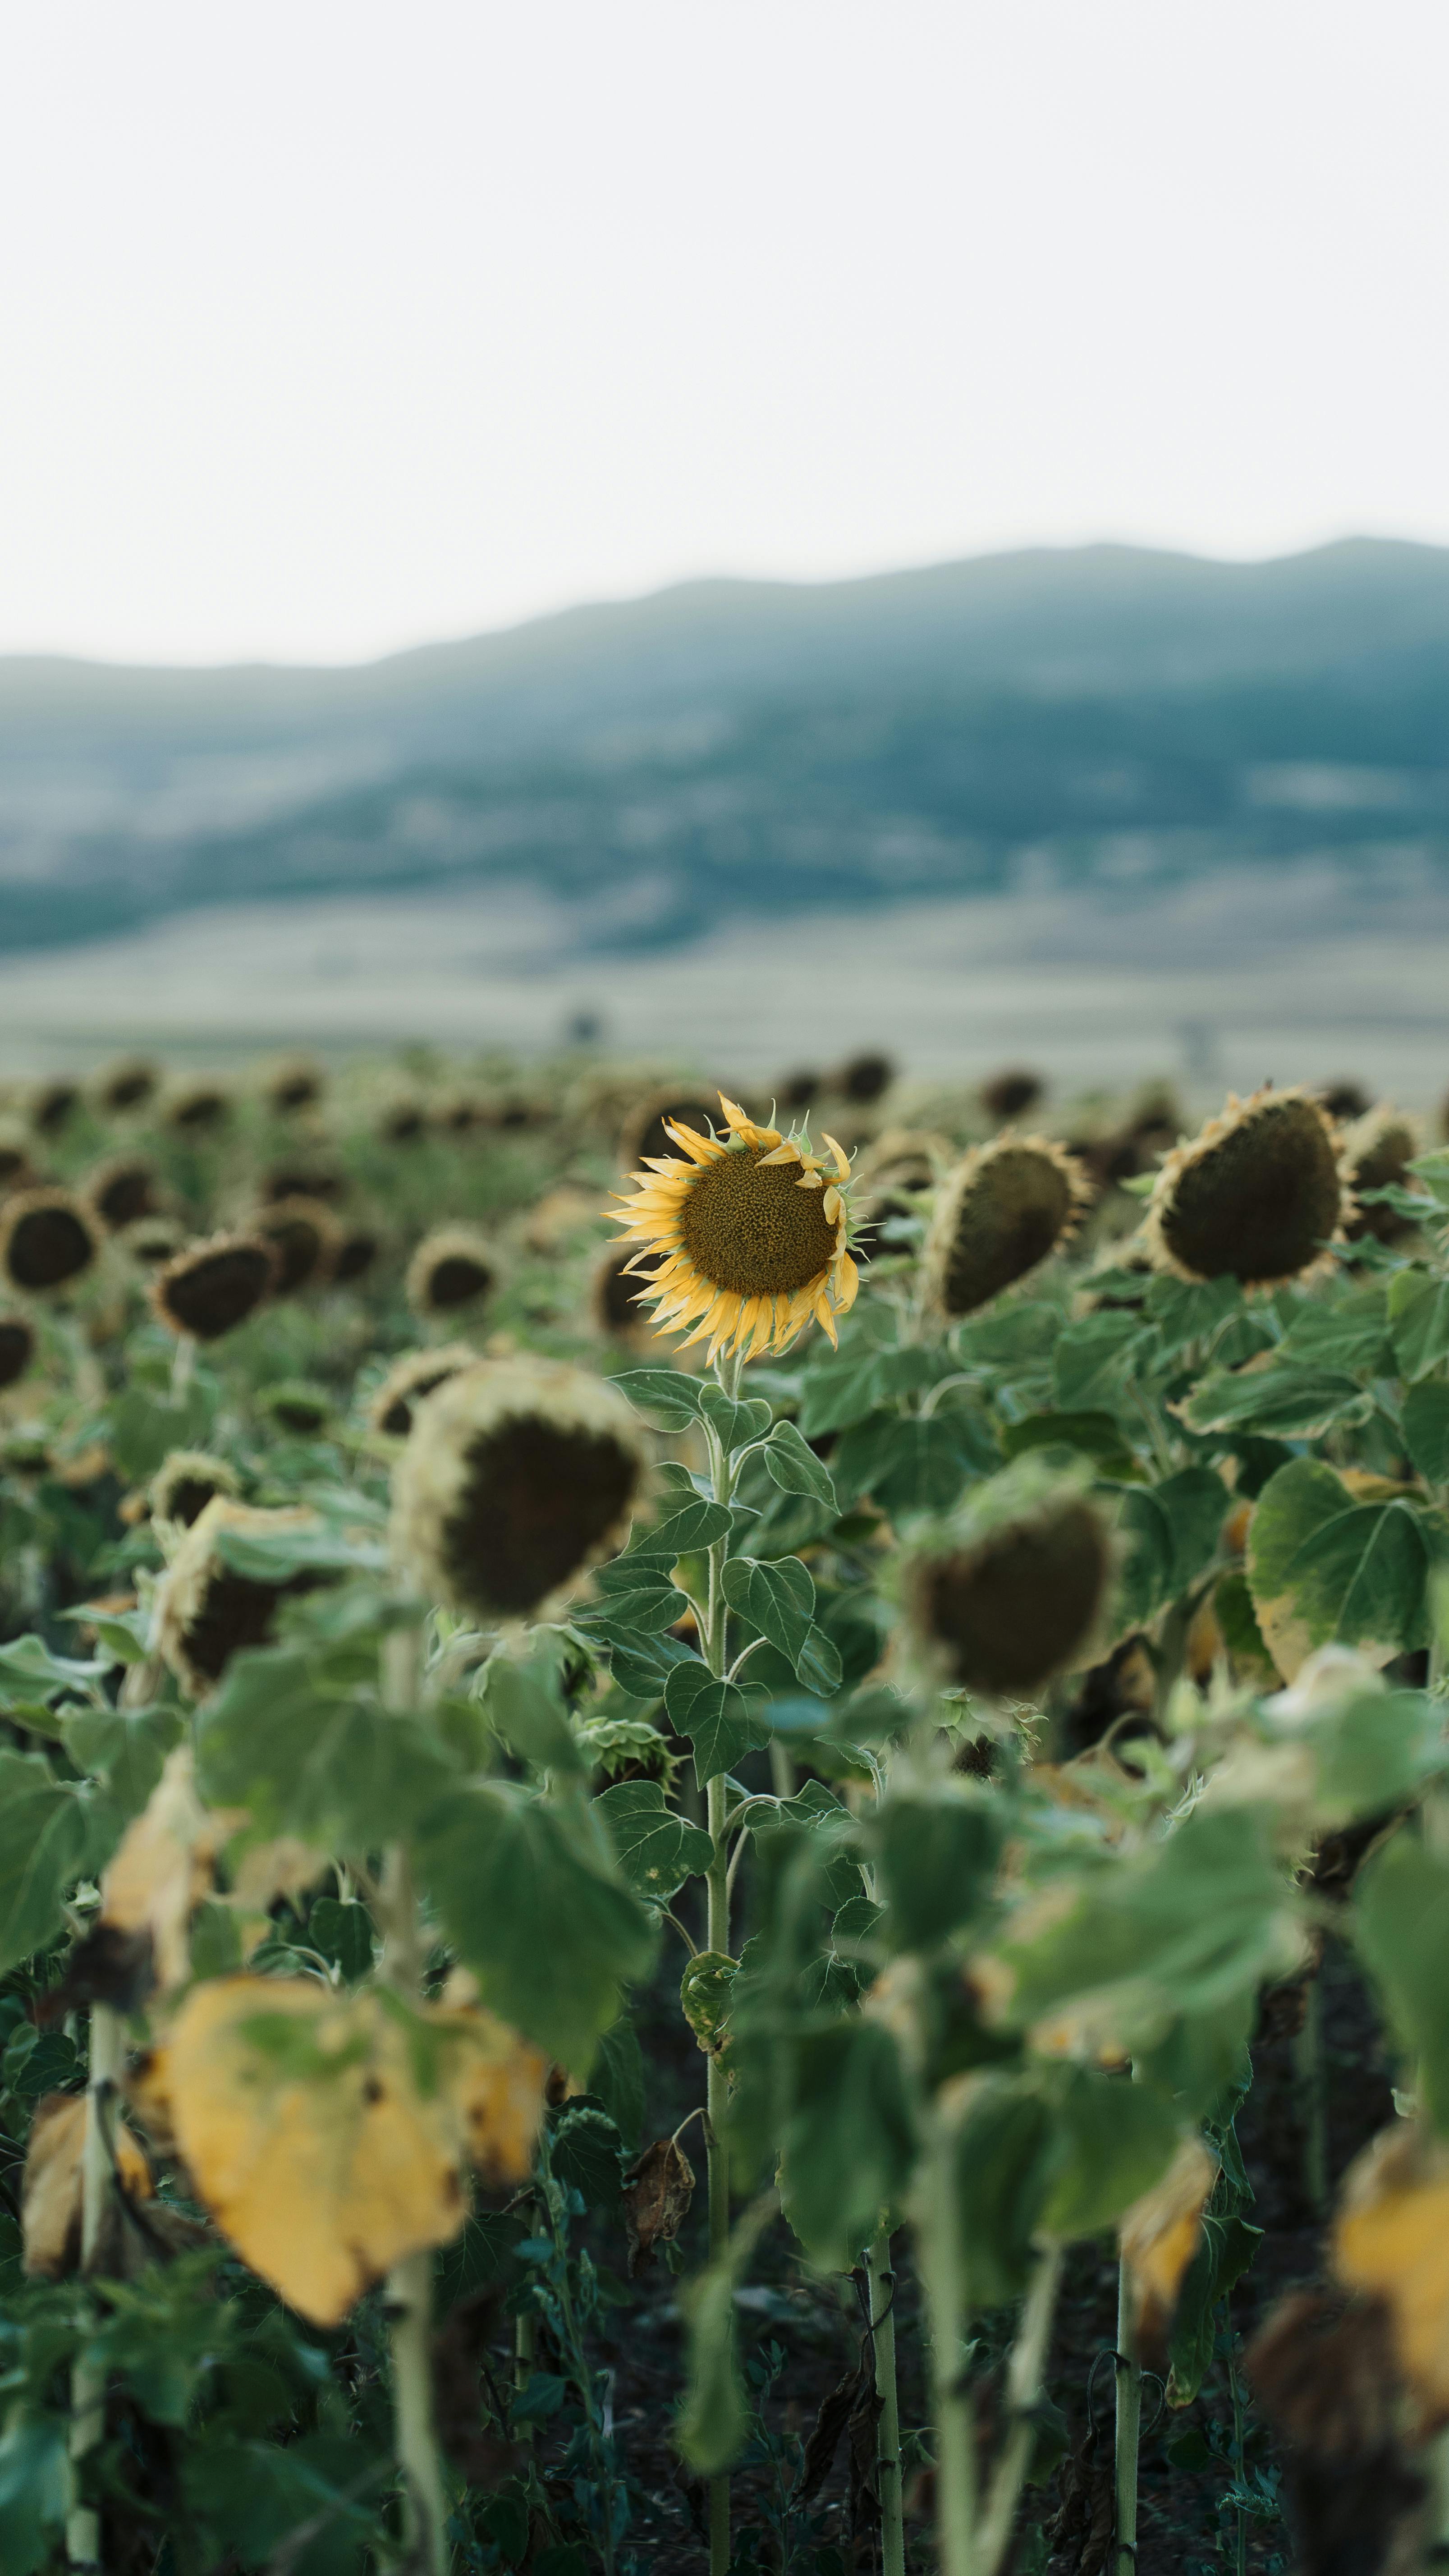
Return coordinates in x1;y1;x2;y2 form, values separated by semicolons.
780;2015;916;2272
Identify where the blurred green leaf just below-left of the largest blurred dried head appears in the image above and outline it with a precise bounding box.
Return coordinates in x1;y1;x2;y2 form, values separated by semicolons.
196;1646;455;1852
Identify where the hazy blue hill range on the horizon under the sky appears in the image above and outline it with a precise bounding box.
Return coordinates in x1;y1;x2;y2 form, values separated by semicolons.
0;541;1449;953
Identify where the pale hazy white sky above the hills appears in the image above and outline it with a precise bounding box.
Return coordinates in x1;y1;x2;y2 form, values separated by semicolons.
0;0;1449;660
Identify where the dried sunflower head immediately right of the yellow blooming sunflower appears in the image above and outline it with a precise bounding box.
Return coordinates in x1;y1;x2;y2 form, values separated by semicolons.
926;1136;1091;1314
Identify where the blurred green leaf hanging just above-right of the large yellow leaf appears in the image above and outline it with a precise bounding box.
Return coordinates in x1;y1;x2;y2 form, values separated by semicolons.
414;1780;654;2066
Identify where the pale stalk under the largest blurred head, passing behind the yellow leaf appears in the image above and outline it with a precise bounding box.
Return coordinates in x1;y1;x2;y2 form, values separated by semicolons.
378;1628;453;2576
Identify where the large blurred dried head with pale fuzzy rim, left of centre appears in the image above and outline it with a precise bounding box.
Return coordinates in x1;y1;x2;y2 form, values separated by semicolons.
394;1358;646;1620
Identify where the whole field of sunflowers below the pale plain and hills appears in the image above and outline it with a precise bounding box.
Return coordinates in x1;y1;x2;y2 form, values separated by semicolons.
0;1048;1449;2576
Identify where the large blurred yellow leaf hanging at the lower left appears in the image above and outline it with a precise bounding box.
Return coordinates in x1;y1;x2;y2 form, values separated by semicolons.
162;1976;546;2326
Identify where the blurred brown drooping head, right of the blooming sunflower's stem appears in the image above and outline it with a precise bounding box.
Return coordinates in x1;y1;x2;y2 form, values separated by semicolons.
901;1460;1112;1700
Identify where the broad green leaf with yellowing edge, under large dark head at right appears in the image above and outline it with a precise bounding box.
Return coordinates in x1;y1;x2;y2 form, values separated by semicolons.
1248;1458;1441;1672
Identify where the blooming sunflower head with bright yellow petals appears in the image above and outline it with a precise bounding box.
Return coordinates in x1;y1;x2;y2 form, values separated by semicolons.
613;1092;860;1360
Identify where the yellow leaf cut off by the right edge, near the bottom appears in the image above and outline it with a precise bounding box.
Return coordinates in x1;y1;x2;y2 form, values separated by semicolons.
1333;2120;1449;2432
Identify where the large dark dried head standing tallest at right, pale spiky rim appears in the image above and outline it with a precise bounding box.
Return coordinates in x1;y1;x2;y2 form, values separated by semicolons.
1143;1090;1354;1288
